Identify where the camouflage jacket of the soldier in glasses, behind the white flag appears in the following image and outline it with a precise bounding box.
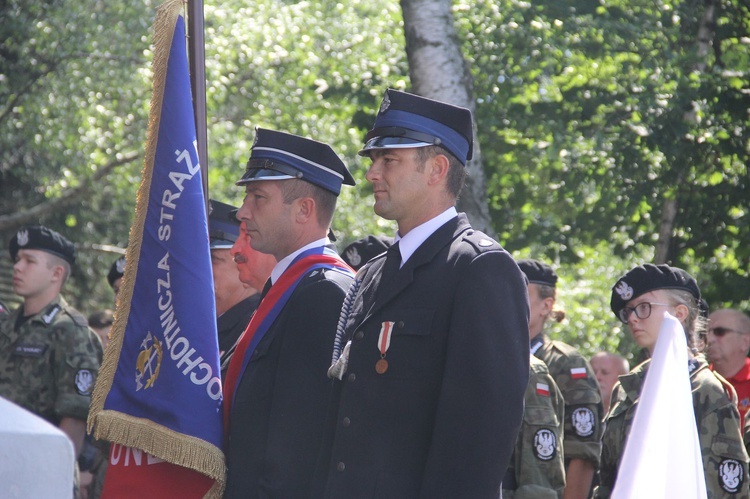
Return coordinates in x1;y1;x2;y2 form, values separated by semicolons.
594;356;748;499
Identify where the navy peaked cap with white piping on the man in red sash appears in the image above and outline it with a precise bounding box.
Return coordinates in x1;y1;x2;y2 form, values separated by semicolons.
237;128;354;196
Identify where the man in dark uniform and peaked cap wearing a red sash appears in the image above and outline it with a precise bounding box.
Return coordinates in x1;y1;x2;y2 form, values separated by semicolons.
224;128;354;499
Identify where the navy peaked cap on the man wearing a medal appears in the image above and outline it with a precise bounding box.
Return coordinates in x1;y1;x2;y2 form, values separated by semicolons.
359;88;474;165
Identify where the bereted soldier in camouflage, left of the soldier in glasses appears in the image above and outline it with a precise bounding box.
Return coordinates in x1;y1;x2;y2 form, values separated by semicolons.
518;259;604;498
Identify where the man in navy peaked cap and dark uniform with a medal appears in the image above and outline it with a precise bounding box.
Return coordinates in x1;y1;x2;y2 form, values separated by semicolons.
316;89;529;499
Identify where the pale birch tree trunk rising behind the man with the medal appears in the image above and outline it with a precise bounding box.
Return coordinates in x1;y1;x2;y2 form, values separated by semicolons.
401;0;495;236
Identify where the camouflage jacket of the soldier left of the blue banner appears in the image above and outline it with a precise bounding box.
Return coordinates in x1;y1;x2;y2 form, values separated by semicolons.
0;296;102;426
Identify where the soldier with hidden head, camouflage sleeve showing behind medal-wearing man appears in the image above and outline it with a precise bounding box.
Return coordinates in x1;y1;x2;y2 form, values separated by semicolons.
503;355;565;499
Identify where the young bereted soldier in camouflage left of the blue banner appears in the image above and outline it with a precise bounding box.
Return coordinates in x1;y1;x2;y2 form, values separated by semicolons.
0;226;102;456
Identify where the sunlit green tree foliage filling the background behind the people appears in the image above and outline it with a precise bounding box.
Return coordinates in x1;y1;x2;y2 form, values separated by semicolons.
0;0;750;362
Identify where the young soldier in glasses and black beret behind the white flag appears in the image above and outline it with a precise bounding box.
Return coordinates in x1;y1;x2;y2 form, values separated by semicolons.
594;264;748;499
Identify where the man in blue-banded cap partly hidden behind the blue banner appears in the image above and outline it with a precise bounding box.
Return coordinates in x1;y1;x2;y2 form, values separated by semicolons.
208;199;271;376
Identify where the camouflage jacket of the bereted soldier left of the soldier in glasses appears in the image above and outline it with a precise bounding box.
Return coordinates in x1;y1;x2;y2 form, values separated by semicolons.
531;334;604;467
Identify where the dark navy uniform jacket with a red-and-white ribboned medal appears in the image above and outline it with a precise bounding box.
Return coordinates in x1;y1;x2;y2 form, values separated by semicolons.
319;214;529;499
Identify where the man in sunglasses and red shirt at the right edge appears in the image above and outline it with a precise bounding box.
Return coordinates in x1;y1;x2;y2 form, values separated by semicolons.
704;308;750;427
